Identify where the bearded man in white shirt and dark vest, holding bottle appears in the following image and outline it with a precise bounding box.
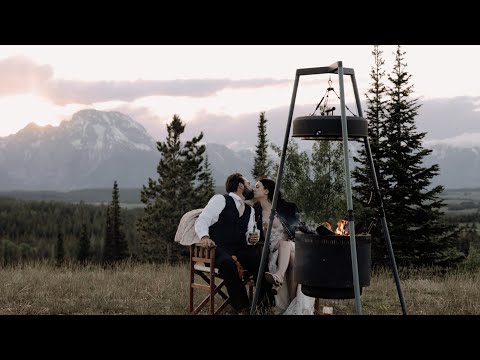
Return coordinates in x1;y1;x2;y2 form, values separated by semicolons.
195;173;266;314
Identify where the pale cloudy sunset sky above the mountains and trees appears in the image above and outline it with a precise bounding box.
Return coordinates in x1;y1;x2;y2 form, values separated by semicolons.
0;45;480;149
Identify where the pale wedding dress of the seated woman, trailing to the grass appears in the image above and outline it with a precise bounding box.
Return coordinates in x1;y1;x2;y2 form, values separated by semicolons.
268;226;315;315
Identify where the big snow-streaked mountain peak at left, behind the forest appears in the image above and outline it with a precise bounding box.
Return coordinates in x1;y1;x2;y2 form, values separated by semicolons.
0;110;159;190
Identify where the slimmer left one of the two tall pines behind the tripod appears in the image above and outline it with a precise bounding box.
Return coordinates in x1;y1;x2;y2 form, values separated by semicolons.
352;45;388;259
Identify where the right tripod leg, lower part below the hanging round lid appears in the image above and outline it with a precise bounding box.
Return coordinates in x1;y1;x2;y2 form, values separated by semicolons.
364;137;407;315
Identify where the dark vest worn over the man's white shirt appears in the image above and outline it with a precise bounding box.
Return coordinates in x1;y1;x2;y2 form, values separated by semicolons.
209;194;252;249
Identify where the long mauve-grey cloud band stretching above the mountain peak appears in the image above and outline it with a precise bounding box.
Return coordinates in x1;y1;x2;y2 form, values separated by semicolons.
0;57;291;105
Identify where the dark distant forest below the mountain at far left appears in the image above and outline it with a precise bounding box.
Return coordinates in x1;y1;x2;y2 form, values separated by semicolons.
0;198;143;264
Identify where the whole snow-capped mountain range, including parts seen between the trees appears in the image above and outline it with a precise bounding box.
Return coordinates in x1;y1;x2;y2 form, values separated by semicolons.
0;110;480;191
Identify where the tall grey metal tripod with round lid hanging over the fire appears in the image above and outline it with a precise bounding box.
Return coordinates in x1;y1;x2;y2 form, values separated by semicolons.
250;61;407;315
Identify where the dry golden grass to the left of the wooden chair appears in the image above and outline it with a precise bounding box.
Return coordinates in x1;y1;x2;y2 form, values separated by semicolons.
0;263;188;315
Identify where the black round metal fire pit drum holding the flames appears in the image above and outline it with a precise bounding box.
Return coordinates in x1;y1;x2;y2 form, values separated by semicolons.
295;232;371;299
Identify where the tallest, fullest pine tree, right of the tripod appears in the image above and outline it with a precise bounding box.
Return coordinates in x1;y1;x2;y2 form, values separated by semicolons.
380;46;460;265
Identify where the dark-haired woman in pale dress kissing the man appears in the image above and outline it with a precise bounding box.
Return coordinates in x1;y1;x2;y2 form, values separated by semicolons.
253;178;315;314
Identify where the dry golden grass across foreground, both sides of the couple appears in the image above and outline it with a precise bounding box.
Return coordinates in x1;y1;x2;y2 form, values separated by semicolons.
0;263;480;315
